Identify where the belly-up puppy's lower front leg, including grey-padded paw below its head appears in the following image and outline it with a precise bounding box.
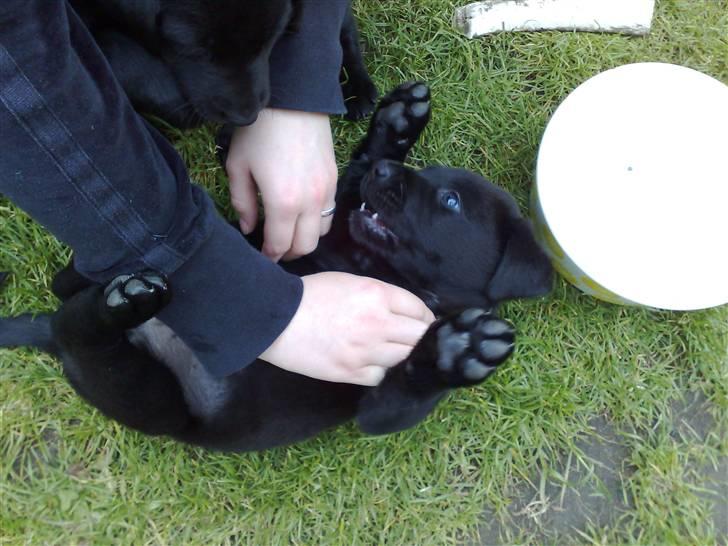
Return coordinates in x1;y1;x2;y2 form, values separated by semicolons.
357;309;514;434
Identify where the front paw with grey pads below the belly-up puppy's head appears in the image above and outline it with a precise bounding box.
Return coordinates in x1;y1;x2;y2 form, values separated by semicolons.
436;309;515;387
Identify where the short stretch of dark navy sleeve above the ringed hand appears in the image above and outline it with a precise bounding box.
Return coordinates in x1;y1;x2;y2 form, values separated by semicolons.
269;0;349;114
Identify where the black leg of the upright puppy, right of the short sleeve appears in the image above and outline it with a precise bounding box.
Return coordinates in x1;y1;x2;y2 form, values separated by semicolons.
341;5;378;121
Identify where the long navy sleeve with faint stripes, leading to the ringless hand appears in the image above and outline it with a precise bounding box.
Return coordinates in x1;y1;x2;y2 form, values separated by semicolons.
0;0;318;375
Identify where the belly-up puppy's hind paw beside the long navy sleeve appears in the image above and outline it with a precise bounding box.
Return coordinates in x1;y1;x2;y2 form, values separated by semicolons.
101;271;171;329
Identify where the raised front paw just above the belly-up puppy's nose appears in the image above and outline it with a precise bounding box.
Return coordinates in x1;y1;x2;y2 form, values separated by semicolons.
363;82;430;161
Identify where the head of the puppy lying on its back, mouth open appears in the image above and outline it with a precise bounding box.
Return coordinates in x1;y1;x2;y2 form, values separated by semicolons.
349;160;552;311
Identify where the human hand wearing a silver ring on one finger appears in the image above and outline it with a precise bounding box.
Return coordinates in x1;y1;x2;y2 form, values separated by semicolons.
225;108;337;261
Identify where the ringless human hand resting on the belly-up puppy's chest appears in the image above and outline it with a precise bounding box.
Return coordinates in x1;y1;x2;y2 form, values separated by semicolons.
260;272;435;386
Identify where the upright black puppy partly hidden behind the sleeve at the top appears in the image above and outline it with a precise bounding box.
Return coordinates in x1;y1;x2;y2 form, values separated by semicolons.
70;0;377;128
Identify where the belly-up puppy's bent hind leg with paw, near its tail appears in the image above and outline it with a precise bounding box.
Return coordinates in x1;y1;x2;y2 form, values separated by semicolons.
51;273;190;434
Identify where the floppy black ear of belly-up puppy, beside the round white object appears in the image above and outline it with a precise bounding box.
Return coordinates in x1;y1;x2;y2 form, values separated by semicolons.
487;218;553;302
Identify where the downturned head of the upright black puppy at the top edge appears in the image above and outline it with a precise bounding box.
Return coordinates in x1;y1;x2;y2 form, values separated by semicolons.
157;0;298;125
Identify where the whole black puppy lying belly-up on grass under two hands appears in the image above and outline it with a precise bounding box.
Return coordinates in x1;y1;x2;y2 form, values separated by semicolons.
0;84;551;451
